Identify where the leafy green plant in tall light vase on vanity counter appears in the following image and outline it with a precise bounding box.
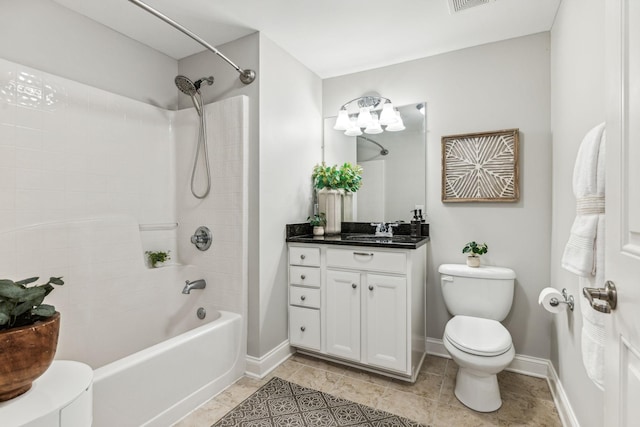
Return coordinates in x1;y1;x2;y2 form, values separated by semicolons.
311;162;342;234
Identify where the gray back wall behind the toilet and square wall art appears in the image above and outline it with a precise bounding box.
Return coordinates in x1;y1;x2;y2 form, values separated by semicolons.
323;33;551;359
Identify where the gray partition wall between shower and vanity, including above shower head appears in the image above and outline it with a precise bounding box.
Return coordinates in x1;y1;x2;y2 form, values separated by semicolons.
179;33;322;358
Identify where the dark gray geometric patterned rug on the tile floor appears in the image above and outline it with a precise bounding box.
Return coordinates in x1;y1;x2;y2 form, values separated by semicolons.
212;377;422;427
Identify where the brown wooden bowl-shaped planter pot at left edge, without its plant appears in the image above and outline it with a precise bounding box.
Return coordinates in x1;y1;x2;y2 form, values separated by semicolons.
0;312;60;402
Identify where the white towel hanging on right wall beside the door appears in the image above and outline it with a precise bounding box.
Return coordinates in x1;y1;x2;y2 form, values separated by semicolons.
562;123;606;390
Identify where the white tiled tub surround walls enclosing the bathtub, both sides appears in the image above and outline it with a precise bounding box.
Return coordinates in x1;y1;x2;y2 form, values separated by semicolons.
0;59;248;367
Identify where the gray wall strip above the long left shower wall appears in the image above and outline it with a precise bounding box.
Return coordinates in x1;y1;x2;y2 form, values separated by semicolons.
0;0;178;109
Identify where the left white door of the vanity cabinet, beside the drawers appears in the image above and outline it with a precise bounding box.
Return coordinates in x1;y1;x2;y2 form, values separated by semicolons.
326;270;361;361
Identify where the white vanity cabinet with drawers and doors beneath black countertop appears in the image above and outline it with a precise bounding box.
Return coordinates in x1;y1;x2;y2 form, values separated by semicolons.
289;243;426;381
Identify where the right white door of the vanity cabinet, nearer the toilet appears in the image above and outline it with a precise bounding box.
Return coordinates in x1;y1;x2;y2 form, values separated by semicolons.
362;273;408;371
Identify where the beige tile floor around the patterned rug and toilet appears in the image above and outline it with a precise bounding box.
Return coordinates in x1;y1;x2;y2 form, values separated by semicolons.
175;354;562;427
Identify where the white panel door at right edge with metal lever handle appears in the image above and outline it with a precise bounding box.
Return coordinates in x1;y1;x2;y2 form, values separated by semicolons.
598;0;640;426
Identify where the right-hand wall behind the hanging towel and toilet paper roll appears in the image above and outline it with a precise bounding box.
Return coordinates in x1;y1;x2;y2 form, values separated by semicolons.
550;0;606;427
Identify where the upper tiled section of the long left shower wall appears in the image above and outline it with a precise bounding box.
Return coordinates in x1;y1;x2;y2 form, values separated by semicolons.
0;59;175;234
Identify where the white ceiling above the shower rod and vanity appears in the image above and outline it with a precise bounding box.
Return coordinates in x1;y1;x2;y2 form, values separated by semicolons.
55;0;561;78
